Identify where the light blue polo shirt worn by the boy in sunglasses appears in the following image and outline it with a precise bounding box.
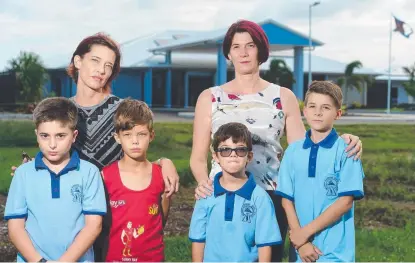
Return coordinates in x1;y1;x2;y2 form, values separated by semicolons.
189;173;282;262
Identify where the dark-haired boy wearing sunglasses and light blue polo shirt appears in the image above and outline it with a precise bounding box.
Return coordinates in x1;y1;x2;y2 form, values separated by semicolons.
189;123;282;262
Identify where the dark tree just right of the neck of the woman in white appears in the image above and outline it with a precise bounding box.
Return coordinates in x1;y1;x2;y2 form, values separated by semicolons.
263;59;295;88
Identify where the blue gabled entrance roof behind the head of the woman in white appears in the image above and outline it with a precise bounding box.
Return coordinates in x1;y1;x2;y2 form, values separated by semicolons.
149;19;323;52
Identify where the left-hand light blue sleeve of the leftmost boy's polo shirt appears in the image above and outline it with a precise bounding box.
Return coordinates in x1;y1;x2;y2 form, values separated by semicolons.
4;168;27;220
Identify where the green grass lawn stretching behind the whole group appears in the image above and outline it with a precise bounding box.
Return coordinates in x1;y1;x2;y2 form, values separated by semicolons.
0;121;415;261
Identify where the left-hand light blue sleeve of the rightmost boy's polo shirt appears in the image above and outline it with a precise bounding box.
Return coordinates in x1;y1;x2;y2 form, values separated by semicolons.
276;145;294;202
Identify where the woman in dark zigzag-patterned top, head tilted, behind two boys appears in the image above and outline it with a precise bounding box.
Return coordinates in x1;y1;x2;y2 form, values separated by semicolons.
12;33;179;262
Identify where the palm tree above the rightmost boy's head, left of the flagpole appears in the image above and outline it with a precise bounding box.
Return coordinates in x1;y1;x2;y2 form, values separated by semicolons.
337;60;371;106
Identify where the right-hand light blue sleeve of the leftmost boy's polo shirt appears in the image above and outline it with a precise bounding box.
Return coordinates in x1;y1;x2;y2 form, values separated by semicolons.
82;166;107;215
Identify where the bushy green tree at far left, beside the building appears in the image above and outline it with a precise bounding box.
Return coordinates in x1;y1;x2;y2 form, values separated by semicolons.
8;51;48;102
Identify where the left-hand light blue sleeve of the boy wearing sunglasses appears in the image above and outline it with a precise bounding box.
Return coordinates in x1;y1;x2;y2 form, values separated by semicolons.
189;198;209;243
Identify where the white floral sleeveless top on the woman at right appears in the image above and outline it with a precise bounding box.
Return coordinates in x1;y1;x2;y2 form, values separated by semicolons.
209;84;285;190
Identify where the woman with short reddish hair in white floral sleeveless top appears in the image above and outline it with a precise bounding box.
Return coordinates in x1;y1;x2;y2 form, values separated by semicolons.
190;20;362;262
